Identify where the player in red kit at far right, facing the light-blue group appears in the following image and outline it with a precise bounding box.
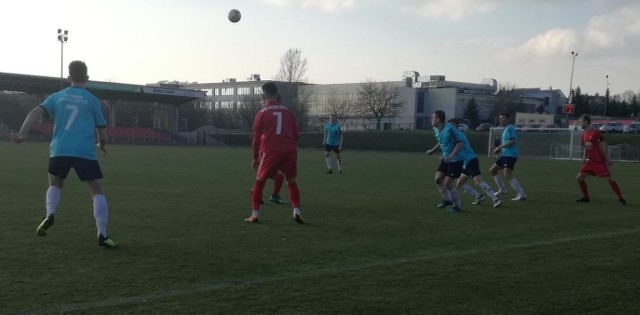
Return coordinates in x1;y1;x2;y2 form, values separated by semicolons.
576;115;627;205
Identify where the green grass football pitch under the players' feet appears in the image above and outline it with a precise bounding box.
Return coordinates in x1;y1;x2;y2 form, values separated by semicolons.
0;141;640;314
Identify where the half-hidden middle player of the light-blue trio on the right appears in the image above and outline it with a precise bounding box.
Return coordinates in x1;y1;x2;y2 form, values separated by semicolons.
449;118;502;208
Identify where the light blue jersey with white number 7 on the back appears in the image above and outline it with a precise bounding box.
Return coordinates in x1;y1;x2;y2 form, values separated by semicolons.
40;86;107;160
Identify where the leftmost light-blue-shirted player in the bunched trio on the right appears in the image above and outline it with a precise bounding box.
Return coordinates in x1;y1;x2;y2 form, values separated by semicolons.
426;110;467;212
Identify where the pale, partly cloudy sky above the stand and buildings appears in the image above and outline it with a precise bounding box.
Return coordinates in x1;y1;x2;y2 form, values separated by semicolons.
0;0;640;95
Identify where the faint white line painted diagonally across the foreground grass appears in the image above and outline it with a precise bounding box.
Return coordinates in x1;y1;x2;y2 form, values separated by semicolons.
20;228;640;314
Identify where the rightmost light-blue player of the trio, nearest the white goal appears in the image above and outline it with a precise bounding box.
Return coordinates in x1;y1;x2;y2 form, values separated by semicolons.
489;113;527;201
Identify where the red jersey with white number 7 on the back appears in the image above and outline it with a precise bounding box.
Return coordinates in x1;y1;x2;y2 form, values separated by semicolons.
252;101;300;159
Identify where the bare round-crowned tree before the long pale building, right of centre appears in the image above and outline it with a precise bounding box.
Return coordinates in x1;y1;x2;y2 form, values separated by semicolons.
356;79;403;130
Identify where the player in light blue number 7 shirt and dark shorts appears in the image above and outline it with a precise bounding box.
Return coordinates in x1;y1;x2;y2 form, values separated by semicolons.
11;61;116;248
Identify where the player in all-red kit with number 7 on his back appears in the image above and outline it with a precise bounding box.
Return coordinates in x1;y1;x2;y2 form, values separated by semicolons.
245;82;304;224
